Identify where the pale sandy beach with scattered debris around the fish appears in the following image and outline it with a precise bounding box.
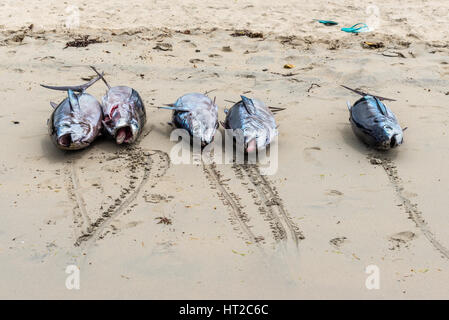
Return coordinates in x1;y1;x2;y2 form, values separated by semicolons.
0;0;449;299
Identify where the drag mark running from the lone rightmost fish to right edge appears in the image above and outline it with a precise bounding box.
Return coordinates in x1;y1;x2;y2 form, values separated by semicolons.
368;154;449;259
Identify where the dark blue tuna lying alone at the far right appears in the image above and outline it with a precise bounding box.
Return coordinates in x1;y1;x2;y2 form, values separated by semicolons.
342;86;405;150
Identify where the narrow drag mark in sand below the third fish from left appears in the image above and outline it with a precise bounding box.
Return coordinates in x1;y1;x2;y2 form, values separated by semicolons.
203;162;258;245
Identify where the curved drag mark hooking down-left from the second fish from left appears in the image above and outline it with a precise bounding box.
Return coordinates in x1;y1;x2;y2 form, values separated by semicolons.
75;146;170;246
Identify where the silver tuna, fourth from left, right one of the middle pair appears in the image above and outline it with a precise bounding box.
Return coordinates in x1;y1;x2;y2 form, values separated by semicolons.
222;96;283;152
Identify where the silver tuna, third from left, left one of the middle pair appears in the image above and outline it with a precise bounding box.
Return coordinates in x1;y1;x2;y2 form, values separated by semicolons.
159;93;218;146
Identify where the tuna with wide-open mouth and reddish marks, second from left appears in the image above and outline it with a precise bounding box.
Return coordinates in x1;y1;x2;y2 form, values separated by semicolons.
91;67;146;144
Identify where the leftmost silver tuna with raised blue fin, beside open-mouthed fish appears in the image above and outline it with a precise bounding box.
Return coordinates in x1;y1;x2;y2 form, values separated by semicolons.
41;76;103;150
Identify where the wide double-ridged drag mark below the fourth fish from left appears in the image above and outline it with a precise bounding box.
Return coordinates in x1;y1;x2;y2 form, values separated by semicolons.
235;164;304;246
